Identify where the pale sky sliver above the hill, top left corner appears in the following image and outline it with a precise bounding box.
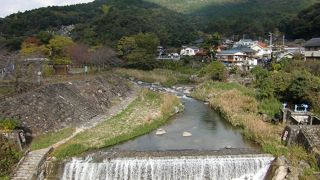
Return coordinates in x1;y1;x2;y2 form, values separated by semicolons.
0;0;93;17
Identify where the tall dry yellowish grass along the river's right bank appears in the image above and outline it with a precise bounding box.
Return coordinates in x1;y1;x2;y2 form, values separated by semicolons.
193;81;316;172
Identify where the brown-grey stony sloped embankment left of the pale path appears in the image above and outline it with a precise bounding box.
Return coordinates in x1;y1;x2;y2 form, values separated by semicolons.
0;75;132;136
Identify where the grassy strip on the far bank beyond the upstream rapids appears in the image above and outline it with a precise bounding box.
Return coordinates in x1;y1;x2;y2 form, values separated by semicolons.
114;68;190;86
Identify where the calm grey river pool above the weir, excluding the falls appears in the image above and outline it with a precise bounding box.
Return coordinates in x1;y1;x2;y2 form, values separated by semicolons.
114;97;253;151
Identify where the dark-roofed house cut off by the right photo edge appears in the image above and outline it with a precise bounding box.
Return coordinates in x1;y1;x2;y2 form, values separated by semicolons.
304;38;320;60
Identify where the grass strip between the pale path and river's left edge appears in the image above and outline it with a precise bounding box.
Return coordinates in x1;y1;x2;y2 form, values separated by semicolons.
53;90;180;159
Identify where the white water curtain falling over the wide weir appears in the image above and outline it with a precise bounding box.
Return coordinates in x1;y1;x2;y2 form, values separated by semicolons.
62;155;274;180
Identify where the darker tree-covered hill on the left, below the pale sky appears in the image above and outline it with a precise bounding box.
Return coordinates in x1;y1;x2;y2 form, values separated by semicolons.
0;0;196;50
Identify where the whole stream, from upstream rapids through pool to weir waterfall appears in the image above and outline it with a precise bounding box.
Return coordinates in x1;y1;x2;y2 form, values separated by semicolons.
58;83;274;180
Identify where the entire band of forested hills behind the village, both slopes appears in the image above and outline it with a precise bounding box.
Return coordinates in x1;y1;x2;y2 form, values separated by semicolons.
0;0;319;50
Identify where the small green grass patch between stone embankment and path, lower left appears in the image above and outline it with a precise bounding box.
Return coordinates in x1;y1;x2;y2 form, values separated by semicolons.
31;128;75;150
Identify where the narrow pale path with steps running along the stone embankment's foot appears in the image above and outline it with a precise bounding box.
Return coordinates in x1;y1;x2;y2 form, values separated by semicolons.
11;87;139;180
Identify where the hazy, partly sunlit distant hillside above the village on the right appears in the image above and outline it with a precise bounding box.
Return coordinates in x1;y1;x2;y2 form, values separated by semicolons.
147;0;317;38
